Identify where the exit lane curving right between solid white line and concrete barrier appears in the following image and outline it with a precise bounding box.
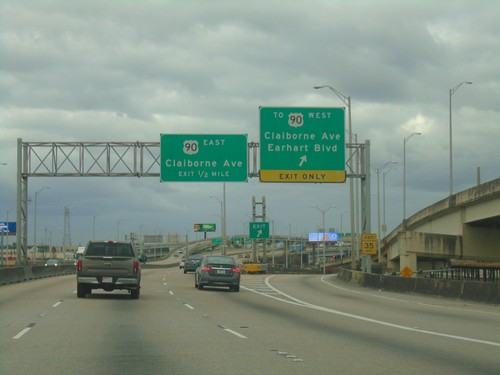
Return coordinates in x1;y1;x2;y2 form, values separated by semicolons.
269;275;500;343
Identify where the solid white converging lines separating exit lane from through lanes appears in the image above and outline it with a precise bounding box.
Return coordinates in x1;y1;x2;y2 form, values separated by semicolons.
245;276;500;347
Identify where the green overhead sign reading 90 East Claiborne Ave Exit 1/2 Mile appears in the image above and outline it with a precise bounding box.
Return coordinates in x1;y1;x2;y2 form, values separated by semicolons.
160;134;248;182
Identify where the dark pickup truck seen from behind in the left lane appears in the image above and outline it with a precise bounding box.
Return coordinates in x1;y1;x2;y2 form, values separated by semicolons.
76;241;141;299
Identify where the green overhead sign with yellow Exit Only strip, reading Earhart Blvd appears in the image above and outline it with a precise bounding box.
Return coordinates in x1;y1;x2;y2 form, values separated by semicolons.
259;107;346;183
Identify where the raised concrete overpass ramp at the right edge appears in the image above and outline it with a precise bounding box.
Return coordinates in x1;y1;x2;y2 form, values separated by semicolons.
381;179;500;273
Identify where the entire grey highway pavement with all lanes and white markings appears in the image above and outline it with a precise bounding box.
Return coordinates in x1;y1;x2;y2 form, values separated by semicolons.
0;268;500;375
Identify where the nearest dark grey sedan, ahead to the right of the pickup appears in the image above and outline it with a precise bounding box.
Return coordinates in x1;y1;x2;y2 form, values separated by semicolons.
194;255;241;292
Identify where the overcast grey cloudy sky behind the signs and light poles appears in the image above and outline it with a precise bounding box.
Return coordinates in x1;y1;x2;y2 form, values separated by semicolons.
0;0;500;248
